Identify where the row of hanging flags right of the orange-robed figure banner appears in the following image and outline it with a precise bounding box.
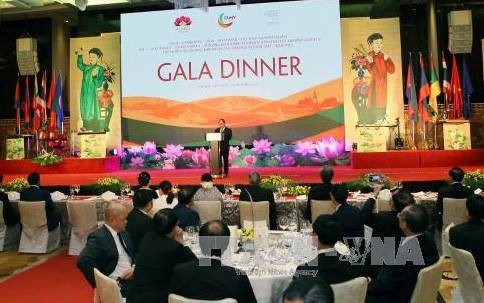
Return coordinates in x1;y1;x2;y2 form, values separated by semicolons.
405;53;474;123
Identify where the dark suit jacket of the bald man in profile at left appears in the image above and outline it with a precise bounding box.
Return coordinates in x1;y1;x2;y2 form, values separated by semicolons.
77;226;135;287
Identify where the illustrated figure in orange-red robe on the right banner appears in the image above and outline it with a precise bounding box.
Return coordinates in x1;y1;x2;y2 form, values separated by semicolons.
366;33;395;124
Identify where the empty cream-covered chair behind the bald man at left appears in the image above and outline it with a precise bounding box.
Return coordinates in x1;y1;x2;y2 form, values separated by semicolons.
67;201;98;256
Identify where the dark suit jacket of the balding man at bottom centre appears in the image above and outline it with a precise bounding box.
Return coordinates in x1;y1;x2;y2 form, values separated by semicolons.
170;258;257;303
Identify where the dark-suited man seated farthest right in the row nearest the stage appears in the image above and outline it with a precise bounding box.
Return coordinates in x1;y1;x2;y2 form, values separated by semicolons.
436;167;472;230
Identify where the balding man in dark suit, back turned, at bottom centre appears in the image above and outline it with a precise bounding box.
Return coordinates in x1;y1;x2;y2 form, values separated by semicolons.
170;220;257;303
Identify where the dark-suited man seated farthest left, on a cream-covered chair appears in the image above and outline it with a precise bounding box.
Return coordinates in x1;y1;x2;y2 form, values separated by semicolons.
20;173;61;231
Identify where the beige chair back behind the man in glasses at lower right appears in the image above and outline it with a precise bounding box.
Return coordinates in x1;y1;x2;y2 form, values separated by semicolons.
410;257;444;303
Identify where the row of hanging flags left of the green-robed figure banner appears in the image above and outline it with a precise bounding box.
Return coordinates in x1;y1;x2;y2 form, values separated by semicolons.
14;71;64;134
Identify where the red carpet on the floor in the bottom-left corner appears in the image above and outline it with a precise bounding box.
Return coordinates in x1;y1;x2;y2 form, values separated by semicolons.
0;254;94;303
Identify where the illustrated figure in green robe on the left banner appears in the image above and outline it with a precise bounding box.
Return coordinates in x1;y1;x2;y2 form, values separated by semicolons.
76;48;105;131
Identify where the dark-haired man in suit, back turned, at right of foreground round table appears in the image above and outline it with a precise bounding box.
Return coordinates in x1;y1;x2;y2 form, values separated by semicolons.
294;215;360;284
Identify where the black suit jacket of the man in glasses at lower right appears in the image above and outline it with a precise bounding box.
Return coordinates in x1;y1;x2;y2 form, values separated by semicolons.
366;234;439;303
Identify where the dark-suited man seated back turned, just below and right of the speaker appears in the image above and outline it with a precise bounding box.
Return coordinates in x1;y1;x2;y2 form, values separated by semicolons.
240;172;277;230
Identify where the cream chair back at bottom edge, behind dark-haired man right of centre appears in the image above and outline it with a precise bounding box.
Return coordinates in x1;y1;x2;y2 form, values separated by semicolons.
331;277;368;303
